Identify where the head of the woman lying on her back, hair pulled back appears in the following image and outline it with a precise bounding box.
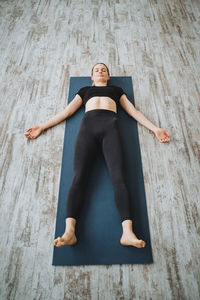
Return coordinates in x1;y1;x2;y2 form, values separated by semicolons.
91;63;110;86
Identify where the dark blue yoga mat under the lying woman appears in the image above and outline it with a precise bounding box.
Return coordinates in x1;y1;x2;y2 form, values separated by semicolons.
52;76;153;266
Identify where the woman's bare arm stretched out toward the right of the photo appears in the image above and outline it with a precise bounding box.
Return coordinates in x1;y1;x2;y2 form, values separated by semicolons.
120;94;170;142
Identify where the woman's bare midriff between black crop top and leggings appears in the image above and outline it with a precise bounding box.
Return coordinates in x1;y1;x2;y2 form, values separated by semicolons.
85;96;117;113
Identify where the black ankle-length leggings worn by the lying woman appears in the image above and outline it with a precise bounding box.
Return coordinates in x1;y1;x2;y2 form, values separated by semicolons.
66;109;132;222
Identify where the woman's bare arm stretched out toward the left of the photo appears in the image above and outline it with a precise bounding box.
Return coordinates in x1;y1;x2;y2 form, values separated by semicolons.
25;94;82;139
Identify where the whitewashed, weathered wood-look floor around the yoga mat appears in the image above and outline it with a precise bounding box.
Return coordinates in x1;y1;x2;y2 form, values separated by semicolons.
0;0;200;300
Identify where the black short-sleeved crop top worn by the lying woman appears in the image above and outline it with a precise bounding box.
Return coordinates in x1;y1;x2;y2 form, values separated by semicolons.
76;85;126;106
